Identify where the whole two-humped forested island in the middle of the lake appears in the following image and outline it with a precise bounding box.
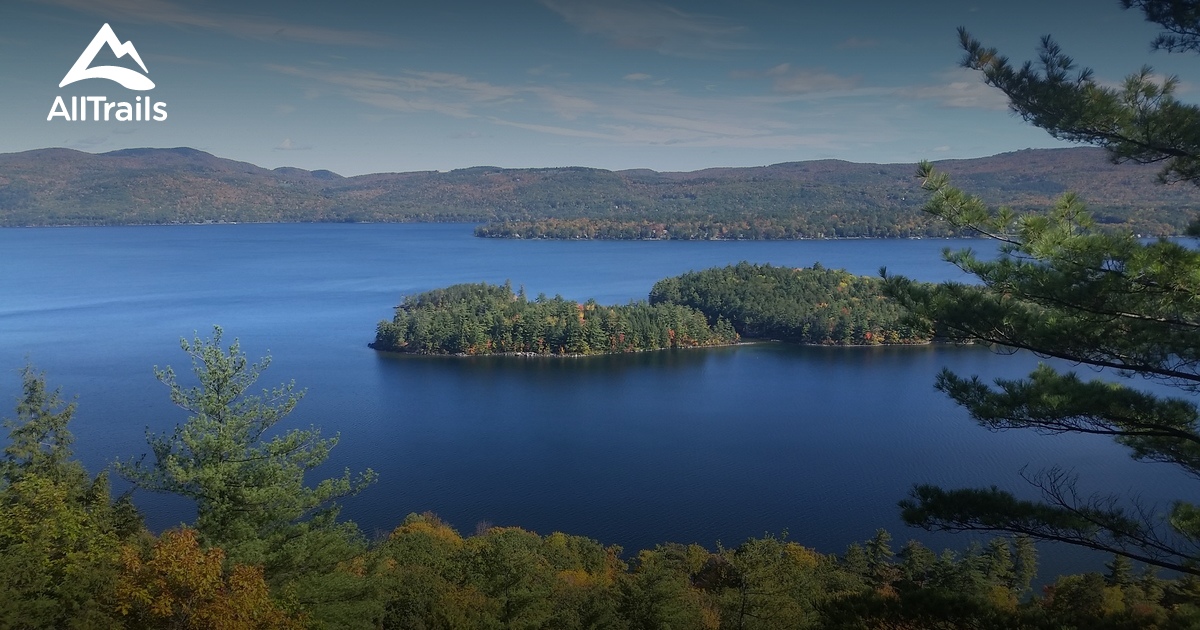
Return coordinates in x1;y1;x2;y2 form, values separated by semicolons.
371;263;930;356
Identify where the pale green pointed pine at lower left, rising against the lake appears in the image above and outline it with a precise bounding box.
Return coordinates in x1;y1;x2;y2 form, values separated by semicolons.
118;326;374;553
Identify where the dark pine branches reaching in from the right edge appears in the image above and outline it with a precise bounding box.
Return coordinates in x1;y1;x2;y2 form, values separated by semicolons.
884;0;1200;576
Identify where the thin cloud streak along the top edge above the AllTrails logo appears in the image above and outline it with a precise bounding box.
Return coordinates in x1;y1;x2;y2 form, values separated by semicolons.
26;0;398;48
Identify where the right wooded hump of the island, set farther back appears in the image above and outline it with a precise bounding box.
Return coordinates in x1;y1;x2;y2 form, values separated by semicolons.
650;263;930;344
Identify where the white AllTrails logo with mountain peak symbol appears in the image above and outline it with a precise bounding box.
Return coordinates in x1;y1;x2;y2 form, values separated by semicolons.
46;24;167;122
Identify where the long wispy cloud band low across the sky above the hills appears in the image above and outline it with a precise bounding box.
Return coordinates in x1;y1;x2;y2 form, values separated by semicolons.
264;60;887;150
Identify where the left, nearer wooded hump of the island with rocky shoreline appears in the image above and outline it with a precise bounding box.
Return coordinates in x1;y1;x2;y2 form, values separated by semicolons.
372;283;738;355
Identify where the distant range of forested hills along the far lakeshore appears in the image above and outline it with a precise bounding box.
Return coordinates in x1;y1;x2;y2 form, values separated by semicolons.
0;148;1200;238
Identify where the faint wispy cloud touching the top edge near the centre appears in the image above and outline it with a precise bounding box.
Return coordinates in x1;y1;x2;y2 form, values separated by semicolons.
541;0;749;58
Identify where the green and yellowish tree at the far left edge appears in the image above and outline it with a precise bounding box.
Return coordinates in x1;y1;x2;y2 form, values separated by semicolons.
0;367;142;628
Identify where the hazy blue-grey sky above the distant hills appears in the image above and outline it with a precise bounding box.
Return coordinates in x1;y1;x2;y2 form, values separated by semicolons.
0;0;1196;175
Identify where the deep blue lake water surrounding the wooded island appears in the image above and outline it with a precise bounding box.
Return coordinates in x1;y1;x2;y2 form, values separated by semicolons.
0;224;1187;583
